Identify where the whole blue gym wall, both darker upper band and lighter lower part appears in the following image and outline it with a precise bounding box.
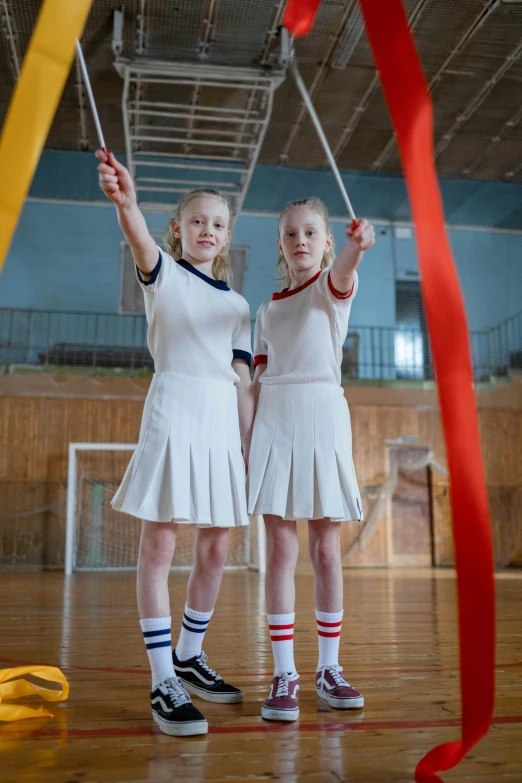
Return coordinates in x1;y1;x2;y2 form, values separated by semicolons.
0;150;522;377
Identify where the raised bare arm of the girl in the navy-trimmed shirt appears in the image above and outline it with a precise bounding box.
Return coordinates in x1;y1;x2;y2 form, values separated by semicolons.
96;150;158;278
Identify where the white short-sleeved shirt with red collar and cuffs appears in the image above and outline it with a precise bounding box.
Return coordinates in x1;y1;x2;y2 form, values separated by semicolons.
254;267;358;386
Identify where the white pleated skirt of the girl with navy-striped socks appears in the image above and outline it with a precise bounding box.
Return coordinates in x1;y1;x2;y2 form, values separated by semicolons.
112;372;248;527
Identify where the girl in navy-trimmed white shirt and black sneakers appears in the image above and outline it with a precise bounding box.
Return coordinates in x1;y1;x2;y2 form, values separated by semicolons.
96;150;253;736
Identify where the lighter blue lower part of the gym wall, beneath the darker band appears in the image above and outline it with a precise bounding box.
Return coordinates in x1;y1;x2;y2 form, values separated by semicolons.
0;202;522;330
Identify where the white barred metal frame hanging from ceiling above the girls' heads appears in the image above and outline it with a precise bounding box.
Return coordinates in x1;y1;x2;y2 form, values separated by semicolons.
115;58;285;215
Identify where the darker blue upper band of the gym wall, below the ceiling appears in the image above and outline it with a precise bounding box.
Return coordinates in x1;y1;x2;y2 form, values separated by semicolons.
30;150;522;230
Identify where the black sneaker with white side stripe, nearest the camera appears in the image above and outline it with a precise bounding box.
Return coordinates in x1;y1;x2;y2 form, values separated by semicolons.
150;677;208;737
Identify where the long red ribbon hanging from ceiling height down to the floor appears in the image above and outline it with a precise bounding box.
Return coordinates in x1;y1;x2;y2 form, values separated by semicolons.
285;0;495;783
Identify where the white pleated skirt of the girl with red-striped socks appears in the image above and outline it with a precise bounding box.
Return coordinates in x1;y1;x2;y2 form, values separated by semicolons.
248;383;362;522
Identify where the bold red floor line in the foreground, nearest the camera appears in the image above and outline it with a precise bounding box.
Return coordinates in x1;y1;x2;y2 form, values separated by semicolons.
4;715;522;742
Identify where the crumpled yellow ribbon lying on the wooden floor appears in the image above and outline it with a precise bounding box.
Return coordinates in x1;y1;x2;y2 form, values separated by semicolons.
0;666;69;721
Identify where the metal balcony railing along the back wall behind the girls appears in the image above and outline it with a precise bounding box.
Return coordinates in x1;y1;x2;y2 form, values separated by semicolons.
0;308;522;382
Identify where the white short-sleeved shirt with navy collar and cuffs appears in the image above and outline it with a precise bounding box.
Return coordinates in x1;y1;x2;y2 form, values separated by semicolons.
136;248;252;383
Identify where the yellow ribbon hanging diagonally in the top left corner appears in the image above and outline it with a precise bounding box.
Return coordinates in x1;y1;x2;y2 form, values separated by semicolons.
0;0;92;271
